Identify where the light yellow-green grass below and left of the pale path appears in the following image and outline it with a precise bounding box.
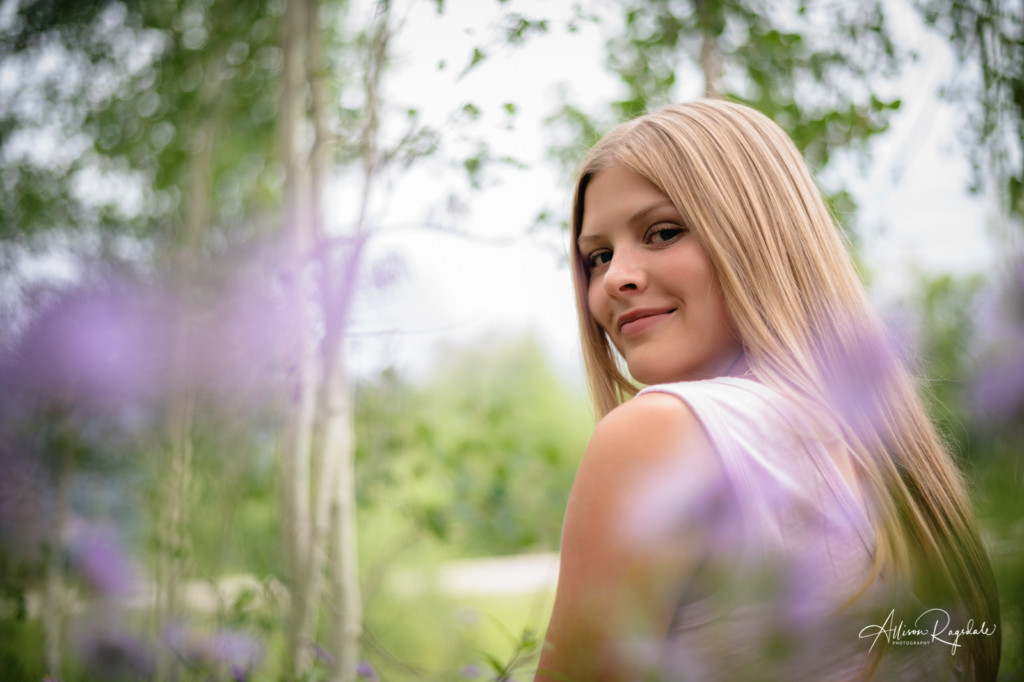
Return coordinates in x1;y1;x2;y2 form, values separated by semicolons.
359;496;554;680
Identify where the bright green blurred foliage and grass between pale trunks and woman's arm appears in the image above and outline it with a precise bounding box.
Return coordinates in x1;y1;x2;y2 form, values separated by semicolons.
356;338;577;679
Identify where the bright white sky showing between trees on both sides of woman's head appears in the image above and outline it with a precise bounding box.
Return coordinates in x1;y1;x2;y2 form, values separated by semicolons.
332;0;994;386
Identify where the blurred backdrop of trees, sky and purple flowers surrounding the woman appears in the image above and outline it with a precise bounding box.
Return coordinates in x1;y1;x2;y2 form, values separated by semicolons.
0;0;1024;681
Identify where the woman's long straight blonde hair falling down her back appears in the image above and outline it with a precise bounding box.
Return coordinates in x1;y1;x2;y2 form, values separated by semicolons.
571;100;1000;680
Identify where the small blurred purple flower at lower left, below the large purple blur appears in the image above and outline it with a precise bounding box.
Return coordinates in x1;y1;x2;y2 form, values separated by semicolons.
68;521;136;597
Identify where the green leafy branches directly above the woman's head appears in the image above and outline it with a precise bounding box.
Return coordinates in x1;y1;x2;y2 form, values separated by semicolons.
549;0;905;240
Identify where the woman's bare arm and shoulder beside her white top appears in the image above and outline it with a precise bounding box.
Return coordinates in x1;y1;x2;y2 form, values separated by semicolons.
536;393;721;680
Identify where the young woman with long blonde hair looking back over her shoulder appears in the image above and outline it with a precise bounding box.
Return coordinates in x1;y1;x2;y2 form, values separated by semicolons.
537;100;1000;680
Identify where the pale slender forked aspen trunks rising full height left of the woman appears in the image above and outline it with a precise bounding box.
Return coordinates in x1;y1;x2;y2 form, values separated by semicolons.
281;0;390;671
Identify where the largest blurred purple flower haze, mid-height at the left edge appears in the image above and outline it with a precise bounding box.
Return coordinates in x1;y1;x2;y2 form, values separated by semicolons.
4;262;288;410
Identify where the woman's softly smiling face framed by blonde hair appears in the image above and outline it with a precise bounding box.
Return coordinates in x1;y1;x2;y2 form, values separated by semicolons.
578;160;742;384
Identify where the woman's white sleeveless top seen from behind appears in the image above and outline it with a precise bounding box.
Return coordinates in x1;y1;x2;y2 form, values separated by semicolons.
637;377;963;681
